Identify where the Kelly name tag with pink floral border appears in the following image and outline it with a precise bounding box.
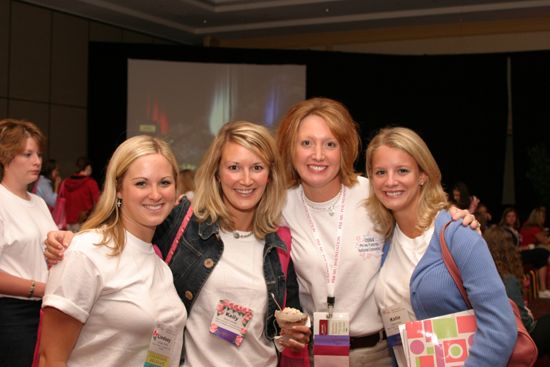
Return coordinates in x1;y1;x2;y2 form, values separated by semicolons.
210;299;253;347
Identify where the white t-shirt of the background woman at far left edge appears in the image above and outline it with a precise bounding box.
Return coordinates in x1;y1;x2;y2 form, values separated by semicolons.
0;185;57;299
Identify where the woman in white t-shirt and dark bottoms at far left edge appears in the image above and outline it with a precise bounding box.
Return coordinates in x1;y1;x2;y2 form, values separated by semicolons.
0;119;56;367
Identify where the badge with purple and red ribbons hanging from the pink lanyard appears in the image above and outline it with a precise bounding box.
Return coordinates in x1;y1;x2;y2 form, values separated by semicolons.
313;312;350;367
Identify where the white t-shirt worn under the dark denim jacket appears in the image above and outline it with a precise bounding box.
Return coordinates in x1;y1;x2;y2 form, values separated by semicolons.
184;231;277;367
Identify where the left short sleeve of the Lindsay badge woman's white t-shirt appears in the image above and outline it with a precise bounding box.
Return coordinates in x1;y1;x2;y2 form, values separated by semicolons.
42;251;103;323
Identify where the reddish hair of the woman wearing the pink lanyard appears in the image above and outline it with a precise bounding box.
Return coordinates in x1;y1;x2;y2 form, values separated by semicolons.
276;98;360;187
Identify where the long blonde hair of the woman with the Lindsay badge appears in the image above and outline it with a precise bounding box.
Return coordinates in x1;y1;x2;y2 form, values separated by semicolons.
81;135;178;256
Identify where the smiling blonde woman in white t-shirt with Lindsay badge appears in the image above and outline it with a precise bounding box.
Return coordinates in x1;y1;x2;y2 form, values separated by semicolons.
40;135;187;367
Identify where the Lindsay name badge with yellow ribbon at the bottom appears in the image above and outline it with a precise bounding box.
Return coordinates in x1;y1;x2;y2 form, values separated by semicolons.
144;324;177;367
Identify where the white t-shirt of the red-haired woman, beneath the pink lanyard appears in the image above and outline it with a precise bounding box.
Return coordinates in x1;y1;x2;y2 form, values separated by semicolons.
283;177;384;336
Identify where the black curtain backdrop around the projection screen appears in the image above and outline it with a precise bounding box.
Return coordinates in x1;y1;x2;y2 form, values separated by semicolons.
88;43;550;220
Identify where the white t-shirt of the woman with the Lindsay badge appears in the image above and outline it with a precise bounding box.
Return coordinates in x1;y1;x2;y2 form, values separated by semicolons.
42;231;187;367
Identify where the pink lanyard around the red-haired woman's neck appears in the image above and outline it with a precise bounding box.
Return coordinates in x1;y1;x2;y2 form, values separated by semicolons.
302;186;346;317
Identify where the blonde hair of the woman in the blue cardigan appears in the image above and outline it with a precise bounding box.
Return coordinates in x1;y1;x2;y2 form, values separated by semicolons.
366;127;449;238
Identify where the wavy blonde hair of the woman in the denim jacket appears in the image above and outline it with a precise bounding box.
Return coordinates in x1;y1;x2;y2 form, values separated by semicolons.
193;121;286;239
